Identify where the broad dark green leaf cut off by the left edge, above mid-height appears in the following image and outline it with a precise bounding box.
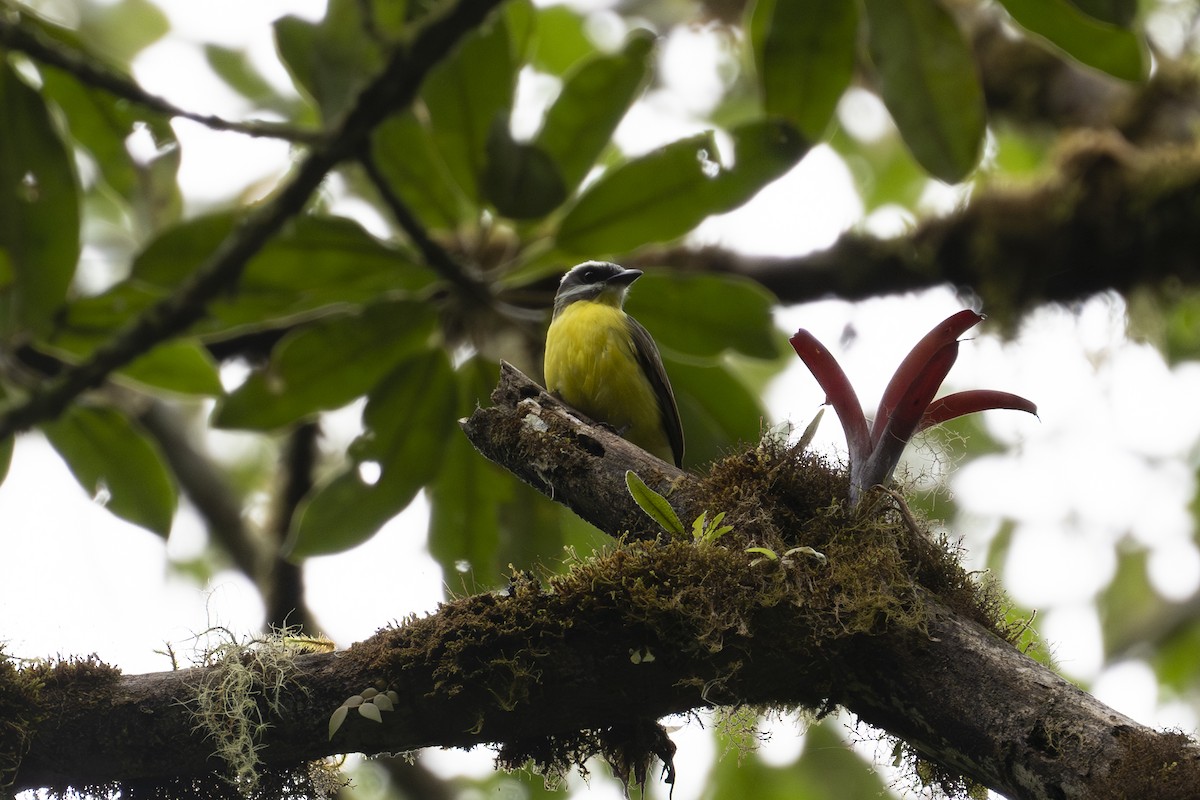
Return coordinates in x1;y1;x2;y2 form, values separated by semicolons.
0;61;79;335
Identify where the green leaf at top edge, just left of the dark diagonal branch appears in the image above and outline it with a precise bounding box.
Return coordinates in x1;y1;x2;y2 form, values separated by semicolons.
275;0;383;122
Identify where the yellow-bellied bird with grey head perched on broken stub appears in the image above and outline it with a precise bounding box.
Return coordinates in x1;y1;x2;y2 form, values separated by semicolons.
544;261;683;467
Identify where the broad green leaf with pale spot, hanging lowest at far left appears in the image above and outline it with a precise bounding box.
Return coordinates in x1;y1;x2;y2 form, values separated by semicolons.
42;405;176;536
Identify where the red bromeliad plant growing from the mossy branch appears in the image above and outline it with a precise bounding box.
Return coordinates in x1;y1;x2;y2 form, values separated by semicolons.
790;311;1038;506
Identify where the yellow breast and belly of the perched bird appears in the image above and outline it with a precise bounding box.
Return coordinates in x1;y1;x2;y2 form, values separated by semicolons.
545;301;673;462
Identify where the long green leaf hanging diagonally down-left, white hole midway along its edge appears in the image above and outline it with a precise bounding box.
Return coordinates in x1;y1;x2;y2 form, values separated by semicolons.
289;349;457;559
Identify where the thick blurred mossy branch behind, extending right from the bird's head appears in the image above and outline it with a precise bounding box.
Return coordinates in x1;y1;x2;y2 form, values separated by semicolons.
626;134;1200;323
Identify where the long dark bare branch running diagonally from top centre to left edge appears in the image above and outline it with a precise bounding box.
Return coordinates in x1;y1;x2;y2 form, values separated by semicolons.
0;0;500;439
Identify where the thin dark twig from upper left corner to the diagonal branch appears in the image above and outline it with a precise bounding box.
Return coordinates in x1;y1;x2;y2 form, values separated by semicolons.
0;17;325;144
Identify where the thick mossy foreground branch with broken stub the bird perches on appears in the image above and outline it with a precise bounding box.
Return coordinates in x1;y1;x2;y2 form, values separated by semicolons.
11;367;1200;800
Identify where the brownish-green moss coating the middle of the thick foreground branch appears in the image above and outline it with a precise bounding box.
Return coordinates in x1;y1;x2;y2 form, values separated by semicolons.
350;439;1019;795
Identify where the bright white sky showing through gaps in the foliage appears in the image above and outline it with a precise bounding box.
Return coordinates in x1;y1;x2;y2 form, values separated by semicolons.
0;0;1200;800
